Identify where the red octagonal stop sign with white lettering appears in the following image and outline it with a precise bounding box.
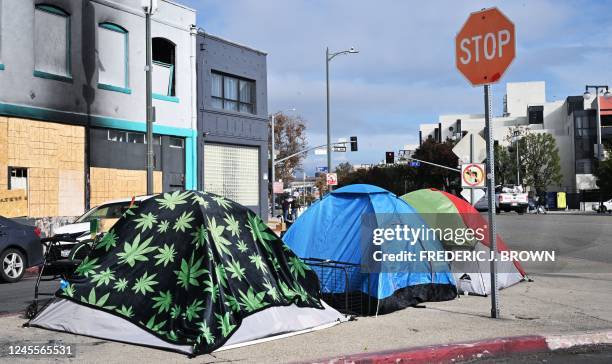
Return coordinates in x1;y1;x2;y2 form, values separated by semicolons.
455;8;515;86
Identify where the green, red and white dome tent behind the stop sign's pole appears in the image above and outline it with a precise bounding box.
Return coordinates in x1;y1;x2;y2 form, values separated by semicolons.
401;189;525;295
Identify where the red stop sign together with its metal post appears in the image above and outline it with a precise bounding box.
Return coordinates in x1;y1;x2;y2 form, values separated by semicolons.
455;8;516;318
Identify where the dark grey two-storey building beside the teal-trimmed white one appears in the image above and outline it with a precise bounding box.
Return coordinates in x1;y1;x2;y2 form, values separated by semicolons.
197;32;269;218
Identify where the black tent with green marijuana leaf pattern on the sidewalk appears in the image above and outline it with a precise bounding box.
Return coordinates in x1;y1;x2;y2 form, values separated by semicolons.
30;191;343;355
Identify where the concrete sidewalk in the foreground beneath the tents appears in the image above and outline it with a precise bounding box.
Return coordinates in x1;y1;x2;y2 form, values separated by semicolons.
0;274;612;363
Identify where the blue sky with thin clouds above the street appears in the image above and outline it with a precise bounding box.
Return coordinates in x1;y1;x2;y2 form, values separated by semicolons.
178;0;612;175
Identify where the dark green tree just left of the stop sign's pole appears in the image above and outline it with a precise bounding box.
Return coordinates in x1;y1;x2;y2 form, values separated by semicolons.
413;139;460;191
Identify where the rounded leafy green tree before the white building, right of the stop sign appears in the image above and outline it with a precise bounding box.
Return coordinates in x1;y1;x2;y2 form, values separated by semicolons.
519;133;563;194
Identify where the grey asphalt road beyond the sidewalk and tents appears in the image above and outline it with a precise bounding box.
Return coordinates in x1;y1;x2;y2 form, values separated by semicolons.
0;212;612;314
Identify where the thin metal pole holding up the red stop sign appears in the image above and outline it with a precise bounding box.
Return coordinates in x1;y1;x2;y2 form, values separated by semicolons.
484;85;499;318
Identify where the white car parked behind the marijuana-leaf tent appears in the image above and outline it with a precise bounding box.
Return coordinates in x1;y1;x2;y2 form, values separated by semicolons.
53;196;151;258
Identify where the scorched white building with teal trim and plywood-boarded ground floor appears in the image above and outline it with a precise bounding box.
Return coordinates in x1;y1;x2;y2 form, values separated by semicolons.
0;0;197;217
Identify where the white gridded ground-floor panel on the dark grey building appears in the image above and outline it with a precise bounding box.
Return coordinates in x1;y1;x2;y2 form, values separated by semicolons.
204;143;259;206
